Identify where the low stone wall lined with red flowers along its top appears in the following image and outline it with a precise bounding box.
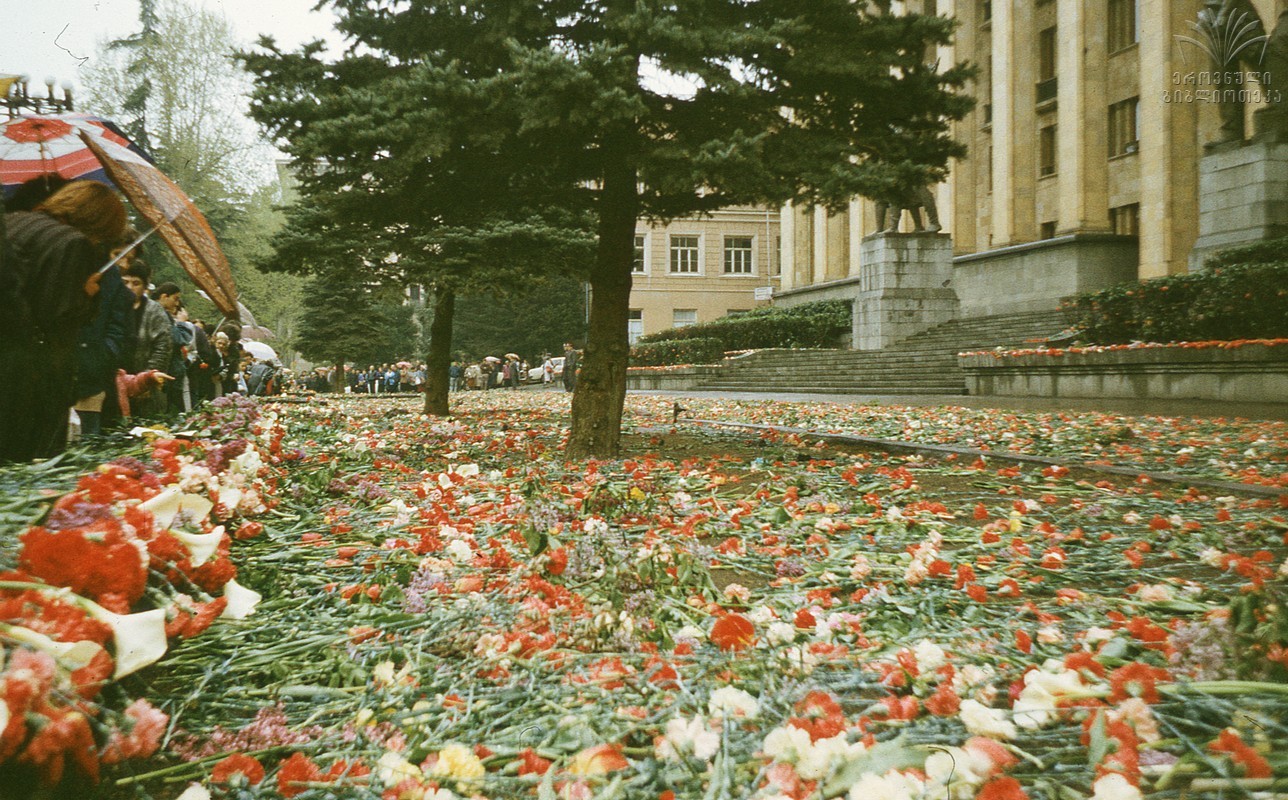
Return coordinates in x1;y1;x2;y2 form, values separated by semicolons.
957;340;1288;403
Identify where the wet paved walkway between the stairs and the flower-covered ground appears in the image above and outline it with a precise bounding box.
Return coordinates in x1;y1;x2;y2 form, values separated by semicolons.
629;389;1288;420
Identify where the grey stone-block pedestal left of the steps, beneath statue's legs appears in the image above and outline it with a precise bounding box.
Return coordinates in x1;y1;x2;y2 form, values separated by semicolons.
851;233;960;350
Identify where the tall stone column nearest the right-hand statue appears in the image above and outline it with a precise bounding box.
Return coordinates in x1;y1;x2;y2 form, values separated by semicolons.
1139;0;1199;280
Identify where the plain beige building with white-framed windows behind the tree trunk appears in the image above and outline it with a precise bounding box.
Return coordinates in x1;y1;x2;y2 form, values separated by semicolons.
630;207;781;344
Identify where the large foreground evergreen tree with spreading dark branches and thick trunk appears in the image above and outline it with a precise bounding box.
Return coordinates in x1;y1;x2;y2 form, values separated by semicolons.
250;0;970;456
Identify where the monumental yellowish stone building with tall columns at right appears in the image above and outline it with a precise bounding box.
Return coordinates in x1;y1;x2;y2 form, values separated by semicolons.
778;0;1288;325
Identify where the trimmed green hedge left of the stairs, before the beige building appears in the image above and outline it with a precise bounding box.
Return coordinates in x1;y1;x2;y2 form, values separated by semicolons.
640;300;850;350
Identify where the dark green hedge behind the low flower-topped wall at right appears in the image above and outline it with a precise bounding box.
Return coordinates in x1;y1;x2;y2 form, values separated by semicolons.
1066;238;1288;344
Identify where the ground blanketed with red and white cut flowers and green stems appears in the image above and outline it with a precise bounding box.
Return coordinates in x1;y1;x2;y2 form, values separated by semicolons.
0;392;1288;800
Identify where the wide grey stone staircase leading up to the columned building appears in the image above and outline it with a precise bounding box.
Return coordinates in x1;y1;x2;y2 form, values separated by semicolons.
697;312;1066;394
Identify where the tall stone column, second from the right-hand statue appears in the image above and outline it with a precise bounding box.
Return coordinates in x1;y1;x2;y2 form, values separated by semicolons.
1056;0;1109;233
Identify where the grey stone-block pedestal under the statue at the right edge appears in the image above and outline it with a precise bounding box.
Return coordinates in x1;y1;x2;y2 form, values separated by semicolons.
1190;140;1288;272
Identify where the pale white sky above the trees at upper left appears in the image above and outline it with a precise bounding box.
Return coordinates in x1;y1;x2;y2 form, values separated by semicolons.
0;0;339;95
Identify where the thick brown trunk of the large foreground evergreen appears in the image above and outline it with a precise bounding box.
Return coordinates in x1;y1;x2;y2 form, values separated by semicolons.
567;129;639;459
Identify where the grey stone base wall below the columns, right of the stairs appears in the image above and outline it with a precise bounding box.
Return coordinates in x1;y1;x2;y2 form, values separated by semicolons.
951;233;1139;318
